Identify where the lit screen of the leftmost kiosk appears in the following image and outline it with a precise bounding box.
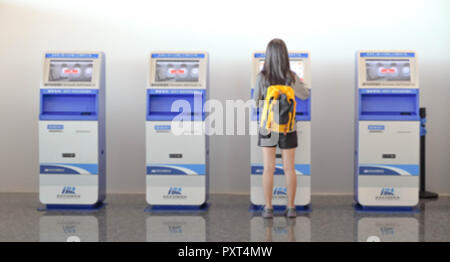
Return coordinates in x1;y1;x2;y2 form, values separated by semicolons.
48;60;94;82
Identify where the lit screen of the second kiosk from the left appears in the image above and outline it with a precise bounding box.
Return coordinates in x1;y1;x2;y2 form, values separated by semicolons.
155;60;199;82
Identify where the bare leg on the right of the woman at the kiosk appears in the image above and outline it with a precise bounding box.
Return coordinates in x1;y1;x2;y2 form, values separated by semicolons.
281;148;297;208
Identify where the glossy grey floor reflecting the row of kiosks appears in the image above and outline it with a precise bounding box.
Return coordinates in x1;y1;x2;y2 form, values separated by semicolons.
0;193;450;241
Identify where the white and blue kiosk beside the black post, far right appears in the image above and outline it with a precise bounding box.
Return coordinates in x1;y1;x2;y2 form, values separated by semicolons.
355;51;420;209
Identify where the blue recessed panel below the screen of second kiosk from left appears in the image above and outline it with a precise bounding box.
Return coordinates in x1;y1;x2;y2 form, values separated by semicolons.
147;89;206;121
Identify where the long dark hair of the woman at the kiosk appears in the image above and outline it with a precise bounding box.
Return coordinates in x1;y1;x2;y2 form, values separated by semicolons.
261;38;295;85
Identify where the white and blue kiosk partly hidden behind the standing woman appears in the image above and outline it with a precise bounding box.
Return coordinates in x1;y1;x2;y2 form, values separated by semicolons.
250;52;311;209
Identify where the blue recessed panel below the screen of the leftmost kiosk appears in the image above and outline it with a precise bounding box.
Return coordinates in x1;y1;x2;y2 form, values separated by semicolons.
39;89;98;121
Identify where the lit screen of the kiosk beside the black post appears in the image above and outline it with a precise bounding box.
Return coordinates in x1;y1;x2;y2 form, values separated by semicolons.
366;59;411;81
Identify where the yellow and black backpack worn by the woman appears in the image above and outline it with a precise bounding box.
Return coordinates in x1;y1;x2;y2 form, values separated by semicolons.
260;85;296;134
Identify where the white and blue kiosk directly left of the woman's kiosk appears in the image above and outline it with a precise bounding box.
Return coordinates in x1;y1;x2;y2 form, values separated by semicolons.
146;52;209;210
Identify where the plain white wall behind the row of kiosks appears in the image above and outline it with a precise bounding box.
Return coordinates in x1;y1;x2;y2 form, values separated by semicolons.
0;0;450;193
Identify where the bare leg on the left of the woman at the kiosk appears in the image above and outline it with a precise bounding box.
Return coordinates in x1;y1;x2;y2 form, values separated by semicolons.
262;147;277;208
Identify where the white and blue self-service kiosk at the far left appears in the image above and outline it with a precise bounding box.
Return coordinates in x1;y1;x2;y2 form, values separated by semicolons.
39;53;106;209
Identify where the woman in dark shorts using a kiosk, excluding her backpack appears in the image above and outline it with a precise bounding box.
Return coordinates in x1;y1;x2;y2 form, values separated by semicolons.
254;39;309;218
